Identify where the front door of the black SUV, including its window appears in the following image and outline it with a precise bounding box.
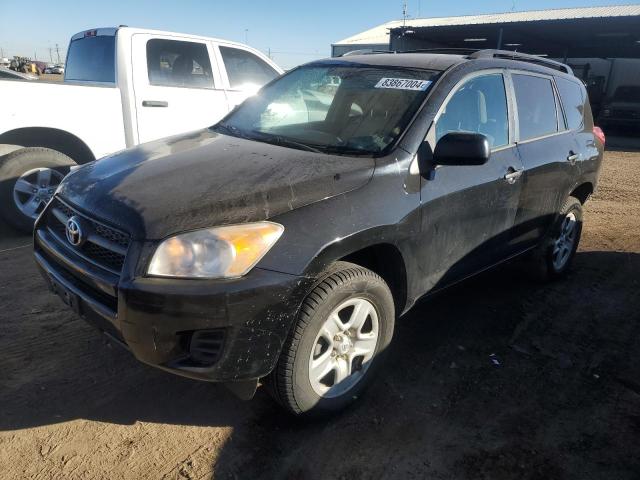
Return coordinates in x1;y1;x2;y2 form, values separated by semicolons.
418;70;522;292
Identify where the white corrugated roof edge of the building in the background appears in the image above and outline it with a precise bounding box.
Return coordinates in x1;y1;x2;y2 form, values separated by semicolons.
334;5;640;45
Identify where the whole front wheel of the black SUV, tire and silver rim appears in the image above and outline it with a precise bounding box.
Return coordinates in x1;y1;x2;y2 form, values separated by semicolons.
265;262;395;416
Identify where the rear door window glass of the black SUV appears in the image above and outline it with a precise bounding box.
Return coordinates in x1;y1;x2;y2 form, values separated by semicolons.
512;74;558;140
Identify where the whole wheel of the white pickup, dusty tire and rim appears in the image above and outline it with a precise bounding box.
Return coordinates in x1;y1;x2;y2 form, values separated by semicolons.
0;147;76;233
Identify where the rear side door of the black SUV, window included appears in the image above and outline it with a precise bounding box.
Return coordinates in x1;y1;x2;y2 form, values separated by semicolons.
511;71;580;250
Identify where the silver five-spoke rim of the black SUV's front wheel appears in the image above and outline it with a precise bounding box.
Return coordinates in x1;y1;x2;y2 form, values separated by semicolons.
309;298;380;398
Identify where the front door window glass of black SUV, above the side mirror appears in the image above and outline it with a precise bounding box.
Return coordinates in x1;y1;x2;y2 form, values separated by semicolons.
436;73;509;148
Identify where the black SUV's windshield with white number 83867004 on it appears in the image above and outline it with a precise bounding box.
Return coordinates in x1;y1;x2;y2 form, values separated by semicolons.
213;64;439;155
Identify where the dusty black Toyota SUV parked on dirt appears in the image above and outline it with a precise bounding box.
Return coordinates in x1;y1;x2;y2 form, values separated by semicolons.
34;51;604;414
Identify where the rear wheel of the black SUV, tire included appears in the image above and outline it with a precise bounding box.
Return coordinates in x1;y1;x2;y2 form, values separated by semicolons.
532;197;582;281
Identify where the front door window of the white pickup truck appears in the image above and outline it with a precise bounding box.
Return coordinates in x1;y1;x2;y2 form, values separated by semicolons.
220;47;280;90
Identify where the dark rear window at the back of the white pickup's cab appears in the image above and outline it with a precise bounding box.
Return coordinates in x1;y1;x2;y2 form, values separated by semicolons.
64;35;116;83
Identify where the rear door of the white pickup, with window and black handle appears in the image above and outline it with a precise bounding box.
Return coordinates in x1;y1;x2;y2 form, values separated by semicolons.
132;34;229;143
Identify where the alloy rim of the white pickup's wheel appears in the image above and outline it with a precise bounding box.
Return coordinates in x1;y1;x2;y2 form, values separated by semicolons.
13;168;64;219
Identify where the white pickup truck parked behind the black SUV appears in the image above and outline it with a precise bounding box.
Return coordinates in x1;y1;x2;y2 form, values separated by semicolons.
0;27;283;230
